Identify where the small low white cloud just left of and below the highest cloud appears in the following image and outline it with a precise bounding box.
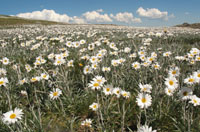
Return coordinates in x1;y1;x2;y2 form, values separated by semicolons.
110;12;142;23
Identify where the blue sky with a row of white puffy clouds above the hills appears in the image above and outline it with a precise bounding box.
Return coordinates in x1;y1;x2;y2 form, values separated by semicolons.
0;0;200;27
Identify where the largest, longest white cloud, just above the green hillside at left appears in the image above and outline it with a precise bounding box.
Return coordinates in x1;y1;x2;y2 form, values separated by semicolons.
16;9;72;22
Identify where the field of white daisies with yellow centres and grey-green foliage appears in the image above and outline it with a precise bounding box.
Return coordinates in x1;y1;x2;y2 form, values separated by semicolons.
0;25;200;132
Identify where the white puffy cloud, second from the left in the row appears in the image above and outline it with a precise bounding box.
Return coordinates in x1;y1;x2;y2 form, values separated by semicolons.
82;9;113;23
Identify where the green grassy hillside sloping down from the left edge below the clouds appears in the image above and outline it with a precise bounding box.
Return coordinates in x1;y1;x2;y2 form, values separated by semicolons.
0;15;67;26
